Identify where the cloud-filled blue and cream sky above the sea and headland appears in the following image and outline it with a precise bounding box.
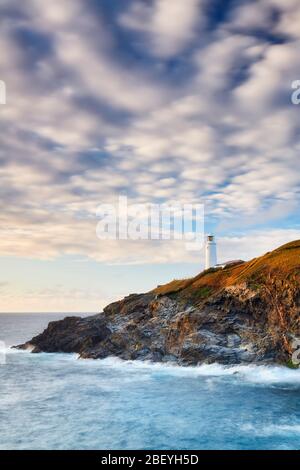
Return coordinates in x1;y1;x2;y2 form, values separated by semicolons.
0;0;300;312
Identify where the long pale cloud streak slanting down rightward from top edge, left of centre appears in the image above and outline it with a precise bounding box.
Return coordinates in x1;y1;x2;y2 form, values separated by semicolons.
32;0;172;112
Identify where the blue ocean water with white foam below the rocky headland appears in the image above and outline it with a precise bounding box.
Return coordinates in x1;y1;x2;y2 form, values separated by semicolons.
0;314;300;450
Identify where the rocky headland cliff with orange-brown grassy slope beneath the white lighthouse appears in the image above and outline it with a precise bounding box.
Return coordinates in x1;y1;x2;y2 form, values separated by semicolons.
17;240;300;364
